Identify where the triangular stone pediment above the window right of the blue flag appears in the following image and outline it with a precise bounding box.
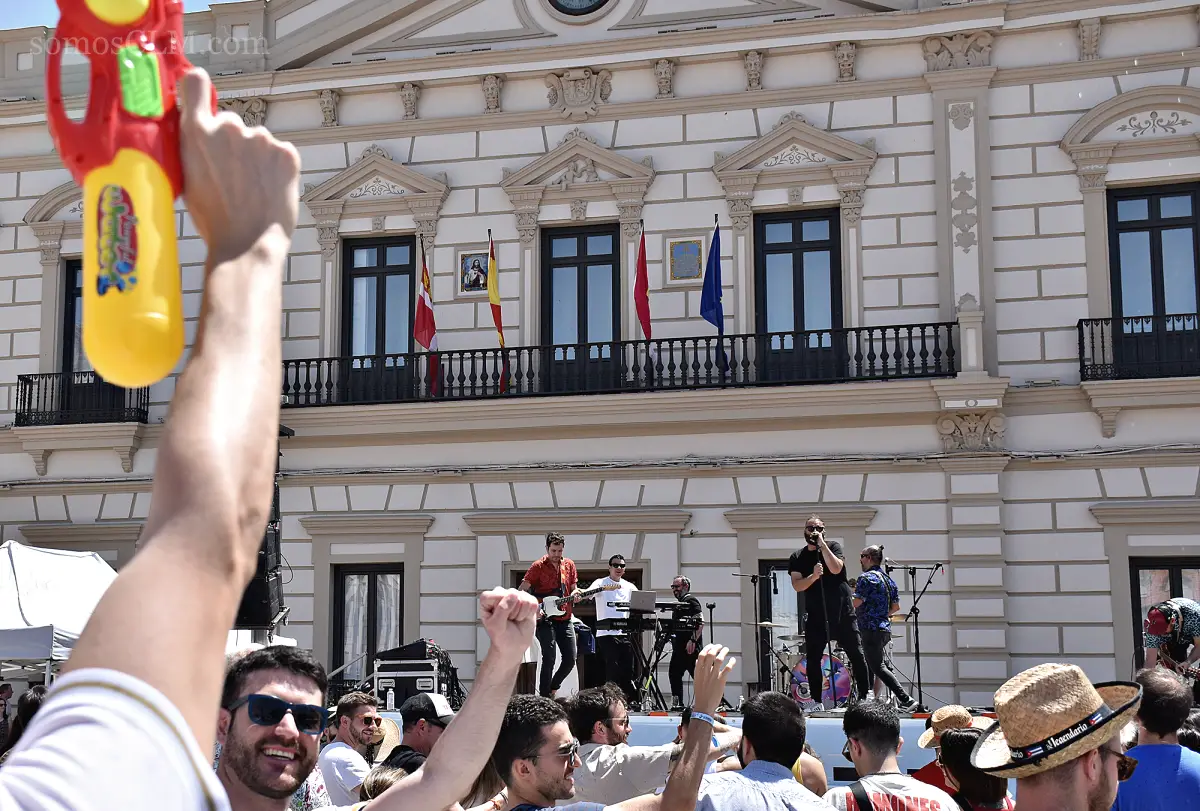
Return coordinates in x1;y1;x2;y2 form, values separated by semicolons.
713;113;876;175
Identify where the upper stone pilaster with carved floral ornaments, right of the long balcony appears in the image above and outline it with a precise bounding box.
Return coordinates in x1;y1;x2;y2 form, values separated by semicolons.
925;60;997;374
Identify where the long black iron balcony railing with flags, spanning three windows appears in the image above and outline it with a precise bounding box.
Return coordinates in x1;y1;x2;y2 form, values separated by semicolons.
283;322;956;407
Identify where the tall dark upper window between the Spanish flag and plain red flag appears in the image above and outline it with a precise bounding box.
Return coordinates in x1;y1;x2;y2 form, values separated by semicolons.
541;224;620;350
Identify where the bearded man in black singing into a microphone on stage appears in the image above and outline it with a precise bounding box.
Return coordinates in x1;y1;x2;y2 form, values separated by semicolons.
787;516;870;702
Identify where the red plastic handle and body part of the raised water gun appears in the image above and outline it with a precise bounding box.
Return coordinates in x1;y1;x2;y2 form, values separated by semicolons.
47;0;217;197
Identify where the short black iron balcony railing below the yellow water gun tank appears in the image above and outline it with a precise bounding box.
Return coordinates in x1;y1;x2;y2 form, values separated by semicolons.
14;372;150;426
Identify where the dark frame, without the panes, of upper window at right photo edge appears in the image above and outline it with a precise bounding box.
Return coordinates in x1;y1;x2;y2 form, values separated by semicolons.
1105;181;1200;323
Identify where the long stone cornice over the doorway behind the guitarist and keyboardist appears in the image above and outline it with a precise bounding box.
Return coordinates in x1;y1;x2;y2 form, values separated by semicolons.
463;507;691;535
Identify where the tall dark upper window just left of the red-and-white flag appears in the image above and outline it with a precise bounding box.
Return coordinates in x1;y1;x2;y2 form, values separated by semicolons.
342;236;415;358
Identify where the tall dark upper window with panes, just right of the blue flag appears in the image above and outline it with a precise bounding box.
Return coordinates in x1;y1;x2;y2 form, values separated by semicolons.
755;209;841;349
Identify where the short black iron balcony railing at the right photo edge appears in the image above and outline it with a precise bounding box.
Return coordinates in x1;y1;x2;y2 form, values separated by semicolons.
1079;313;1200;380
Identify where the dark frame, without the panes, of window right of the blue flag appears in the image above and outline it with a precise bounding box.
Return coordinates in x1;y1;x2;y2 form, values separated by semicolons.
754;206;846;335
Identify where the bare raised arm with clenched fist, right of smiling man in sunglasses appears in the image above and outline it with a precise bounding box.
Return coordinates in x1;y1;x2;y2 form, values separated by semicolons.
371;589;539;811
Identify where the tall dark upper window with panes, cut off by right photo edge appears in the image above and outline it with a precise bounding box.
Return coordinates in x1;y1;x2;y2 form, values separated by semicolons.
1109;184;1200;323
